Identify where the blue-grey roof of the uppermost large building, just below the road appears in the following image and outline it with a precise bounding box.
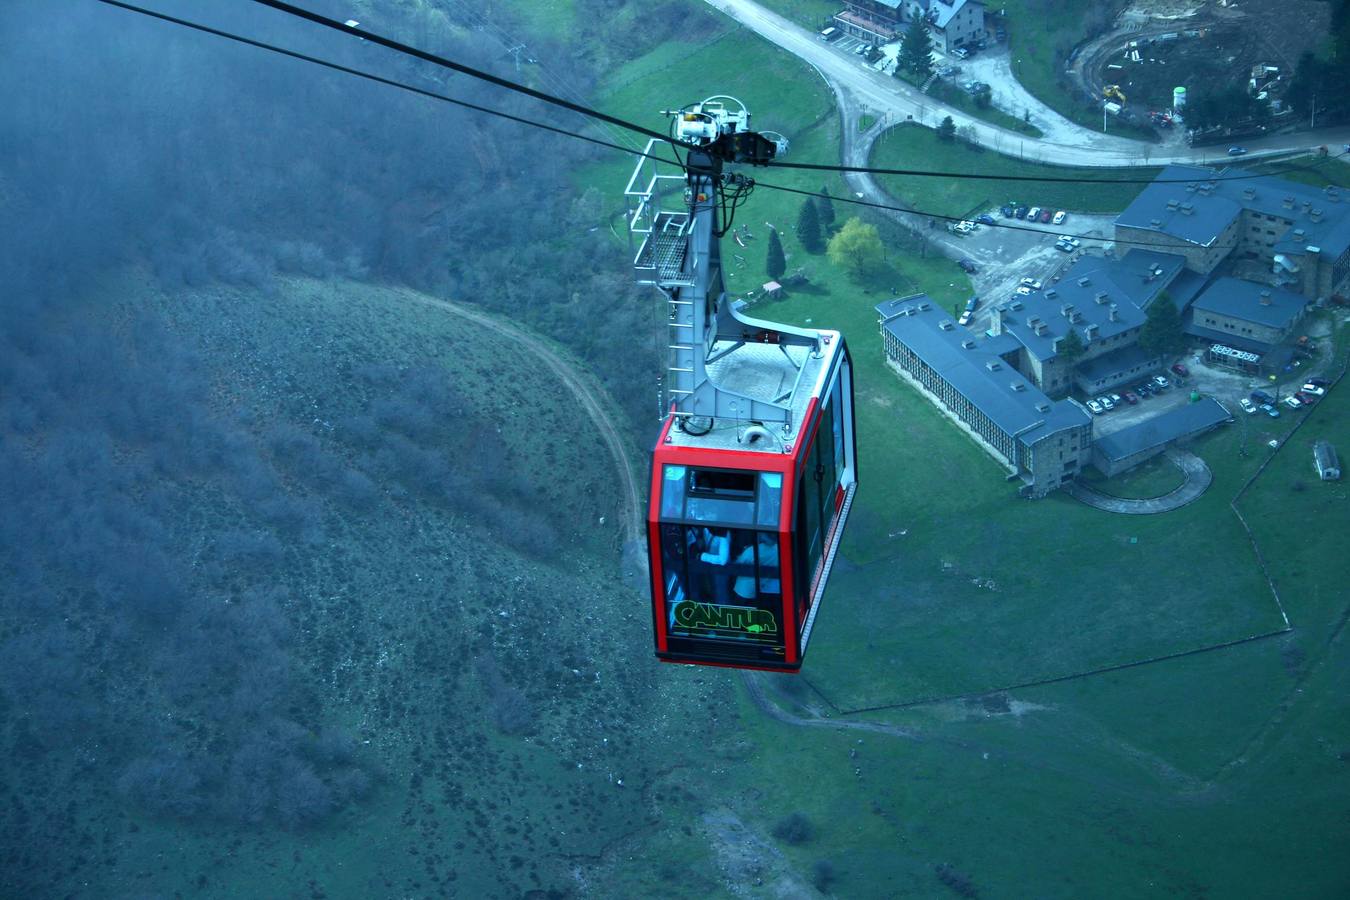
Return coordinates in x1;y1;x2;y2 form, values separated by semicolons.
1115;166;1350;258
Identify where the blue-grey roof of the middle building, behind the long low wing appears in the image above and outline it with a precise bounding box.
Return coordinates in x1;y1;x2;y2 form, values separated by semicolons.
999;256;1144;360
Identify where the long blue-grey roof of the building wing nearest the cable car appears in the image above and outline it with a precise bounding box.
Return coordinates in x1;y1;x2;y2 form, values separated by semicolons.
876;294;1092;445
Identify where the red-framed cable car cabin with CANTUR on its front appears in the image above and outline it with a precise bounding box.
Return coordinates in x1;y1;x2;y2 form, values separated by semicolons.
648;331;857;672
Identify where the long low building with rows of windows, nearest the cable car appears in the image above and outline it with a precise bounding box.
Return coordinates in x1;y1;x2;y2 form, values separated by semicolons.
876;294;1092;497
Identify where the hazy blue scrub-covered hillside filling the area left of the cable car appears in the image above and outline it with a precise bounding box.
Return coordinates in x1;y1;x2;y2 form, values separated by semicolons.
0;0;745;897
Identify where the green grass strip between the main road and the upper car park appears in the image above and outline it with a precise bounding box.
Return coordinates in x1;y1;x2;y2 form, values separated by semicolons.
871;125;1160;216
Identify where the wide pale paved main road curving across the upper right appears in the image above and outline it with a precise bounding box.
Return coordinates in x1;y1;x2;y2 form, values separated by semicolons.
707;0;1350;166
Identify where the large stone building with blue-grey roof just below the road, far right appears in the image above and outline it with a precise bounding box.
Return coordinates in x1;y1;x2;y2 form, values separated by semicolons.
1115;166;1350;300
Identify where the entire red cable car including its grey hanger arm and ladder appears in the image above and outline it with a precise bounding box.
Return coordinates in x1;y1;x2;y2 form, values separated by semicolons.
624;96;857;672
